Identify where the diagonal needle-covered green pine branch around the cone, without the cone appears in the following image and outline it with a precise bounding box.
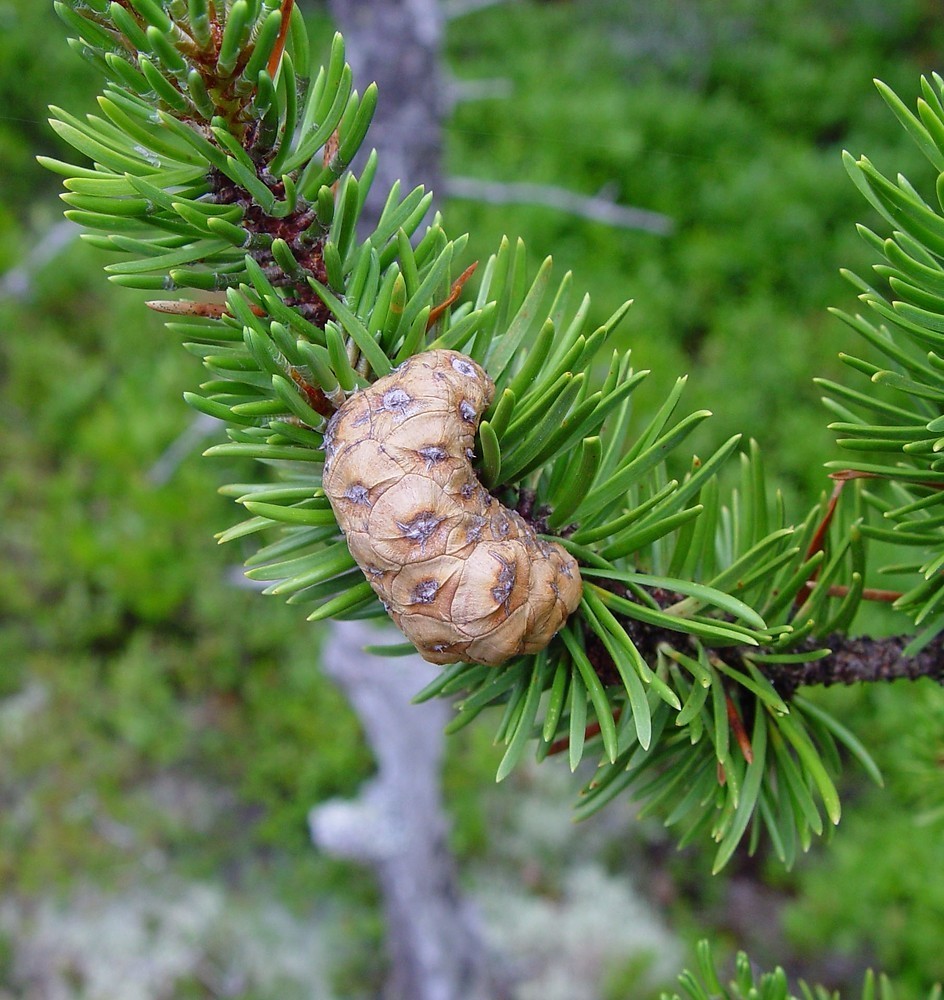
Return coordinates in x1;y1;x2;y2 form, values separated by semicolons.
44;0;944;870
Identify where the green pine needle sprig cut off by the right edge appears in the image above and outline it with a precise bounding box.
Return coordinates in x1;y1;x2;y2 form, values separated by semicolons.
823;74;944;632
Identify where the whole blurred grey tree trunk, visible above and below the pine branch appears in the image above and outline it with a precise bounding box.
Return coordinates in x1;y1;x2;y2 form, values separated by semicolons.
311;0;502;1000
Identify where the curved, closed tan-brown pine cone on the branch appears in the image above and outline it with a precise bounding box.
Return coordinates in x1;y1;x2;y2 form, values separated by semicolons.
323;351;582;665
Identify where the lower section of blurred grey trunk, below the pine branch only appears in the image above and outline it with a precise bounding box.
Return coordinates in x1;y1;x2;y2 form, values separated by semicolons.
309;621;506;1000
